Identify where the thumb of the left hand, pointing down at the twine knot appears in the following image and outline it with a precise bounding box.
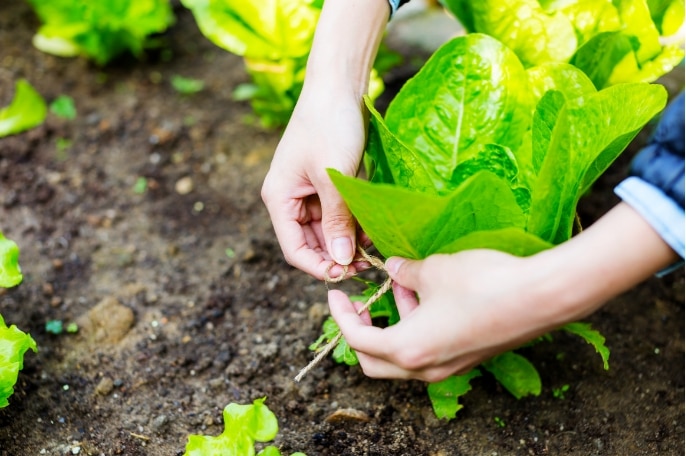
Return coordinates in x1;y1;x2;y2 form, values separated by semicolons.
319;183;356;265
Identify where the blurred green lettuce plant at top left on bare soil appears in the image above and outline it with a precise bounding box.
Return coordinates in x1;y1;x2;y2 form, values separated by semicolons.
27;0;174;65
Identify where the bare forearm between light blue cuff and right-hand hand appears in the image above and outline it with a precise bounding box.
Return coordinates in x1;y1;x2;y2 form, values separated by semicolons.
531;203;679;324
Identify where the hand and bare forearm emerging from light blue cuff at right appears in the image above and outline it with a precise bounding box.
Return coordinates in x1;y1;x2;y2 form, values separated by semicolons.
329;202;679;382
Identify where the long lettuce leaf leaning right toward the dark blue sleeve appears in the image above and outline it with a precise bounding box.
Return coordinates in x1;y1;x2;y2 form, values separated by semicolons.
526;83;667;244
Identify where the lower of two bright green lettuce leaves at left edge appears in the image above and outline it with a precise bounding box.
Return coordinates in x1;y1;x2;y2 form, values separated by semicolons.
0;315;38;408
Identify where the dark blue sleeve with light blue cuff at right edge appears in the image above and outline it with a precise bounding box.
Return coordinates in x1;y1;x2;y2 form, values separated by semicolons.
615;92;686;273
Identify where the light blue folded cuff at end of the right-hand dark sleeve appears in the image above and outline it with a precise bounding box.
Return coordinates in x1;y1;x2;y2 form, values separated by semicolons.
615;176;686;276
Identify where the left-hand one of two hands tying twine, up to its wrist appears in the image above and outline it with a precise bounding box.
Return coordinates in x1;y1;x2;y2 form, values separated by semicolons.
262;85;365;279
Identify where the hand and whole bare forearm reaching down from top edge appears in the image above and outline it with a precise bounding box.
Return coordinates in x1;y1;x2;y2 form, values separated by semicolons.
262;0;390;279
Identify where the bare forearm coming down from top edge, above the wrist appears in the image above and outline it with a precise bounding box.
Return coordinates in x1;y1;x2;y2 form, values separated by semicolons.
303;0;390;100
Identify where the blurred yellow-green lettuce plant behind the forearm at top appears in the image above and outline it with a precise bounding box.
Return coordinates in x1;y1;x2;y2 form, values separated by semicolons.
181;0;393;127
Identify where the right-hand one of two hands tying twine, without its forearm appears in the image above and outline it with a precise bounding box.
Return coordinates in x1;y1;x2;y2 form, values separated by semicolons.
329;250;555;382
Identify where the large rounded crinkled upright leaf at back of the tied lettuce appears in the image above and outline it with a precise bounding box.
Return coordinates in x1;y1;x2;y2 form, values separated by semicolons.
385;34;534;192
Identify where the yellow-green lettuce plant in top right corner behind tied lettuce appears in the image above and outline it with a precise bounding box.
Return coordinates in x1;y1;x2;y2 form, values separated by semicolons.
441;0;684;88
